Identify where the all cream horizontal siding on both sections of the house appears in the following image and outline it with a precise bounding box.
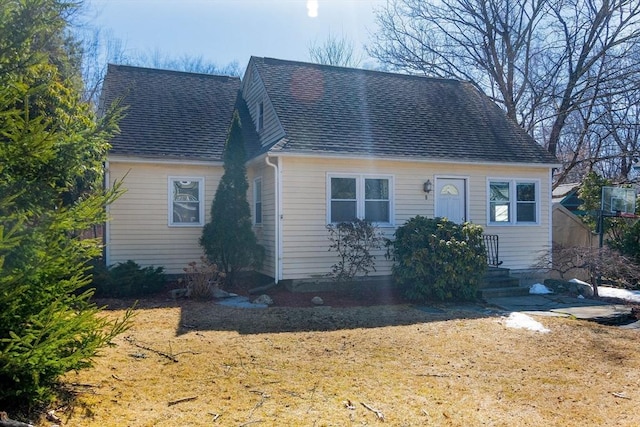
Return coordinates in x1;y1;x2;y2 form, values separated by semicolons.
107;157;551;279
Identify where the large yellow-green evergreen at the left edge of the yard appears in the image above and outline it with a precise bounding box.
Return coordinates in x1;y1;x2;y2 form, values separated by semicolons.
0;0;130;409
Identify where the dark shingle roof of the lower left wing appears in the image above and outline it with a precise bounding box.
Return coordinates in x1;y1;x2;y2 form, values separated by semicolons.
101;64;240;160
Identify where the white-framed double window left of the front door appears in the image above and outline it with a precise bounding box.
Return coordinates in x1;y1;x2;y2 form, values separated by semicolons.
327;175;393;224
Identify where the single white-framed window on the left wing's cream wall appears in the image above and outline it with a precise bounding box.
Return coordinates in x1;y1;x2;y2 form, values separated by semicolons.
169;177;204;226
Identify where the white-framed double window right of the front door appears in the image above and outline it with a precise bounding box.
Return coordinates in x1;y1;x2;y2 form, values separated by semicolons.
489;179;540;224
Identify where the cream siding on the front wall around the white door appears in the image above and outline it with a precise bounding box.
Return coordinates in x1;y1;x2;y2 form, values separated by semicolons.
280;157;551;279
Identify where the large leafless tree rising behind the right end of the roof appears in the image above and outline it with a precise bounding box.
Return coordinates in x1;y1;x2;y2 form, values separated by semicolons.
368;0;640;182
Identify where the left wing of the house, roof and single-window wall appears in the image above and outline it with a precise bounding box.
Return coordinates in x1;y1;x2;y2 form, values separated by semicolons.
99;65;240;274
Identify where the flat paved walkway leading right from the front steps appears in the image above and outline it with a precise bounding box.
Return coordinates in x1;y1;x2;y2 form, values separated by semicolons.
486;294;640;328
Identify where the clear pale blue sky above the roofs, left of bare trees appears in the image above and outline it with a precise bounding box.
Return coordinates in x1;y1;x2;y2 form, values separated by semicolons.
87;0;385;68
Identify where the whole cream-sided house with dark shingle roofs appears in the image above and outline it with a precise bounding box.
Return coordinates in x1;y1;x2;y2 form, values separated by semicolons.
103;57;559;281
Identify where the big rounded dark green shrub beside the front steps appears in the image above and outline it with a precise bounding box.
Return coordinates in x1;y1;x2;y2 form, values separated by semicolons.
389;216;487;301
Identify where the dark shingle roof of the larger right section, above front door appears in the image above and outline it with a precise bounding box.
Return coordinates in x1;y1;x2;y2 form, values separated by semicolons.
250;57;558;164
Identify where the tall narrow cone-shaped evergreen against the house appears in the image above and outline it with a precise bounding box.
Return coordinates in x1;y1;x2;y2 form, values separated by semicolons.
200;113;264;283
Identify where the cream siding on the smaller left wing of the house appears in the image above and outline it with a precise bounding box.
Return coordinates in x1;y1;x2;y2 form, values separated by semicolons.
106;161;223;274
